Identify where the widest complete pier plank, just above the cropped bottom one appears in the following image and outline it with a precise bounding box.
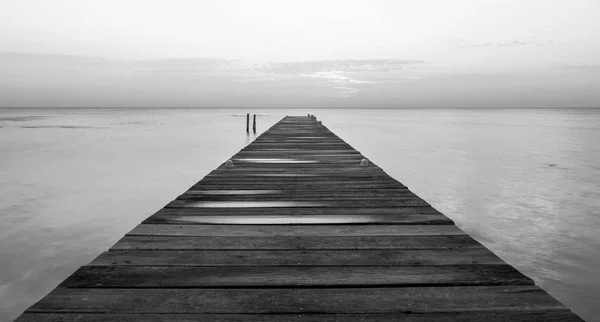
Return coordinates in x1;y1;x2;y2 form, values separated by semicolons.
27;286;565;314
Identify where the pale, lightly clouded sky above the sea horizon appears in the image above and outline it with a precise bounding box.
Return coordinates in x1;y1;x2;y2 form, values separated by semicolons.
0;0;600;108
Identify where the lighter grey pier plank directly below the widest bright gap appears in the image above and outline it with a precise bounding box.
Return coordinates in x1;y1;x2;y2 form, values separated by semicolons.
127;224;466;236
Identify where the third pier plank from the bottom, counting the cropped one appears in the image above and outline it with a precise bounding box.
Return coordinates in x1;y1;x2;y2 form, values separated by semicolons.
60;264;533;288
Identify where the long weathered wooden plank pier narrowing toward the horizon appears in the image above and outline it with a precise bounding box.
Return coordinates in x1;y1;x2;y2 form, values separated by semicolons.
17;116;582;322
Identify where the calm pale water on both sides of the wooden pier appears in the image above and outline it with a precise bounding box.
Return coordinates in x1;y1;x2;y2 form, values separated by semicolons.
0;110;600;321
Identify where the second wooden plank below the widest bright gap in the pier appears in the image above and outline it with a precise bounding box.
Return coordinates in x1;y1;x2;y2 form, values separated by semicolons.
111;236;482;250
